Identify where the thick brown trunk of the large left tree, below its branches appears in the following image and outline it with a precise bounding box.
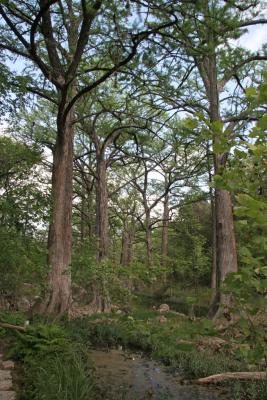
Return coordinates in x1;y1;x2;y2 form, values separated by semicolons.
41;110;74;316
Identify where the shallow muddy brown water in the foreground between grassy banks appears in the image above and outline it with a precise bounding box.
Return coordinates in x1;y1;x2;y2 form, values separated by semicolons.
90;350;226;400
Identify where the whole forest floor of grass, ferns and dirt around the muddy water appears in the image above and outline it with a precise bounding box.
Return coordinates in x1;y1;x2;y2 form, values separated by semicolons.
0;295;267;400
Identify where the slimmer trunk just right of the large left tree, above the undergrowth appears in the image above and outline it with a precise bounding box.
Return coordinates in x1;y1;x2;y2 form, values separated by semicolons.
96;158;109;262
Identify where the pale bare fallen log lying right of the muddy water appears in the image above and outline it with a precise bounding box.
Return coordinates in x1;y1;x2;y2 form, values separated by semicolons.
194;372;267;385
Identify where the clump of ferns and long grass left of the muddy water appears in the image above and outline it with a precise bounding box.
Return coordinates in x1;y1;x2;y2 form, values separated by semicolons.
4;316;93;400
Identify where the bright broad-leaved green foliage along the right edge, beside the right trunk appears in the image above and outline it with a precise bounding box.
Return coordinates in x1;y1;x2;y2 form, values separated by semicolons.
223;73;267;368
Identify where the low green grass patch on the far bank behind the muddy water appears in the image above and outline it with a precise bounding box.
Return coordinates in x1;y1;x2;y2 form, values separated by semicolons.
67;311;242;378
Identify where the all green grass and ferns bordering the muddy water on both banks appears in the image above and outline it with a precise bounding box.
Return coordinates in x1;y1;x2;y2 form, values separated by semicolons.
1;307;267;400
